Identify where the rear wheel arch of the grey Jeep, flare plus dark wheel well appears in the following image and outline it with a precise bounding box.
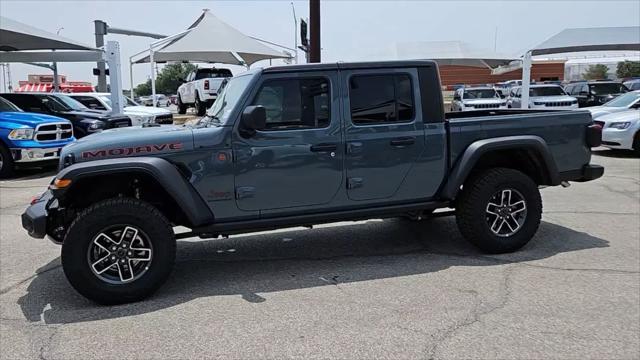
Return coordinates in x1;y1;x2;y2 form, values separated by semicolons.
441;135;560;200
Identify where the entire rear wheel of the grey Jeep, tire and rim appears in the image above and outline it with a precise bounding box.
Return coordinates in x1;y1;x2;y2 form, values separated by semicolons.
456;168;542;253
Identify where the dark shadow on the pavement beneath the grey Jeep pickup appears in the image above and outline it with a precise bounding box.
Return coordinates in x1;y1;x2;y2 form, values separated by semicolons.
18;218;609;324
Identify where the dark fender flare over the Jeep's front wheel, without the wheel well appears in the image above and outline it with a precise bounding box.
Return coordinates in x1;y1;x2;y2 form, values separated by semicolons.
53;157;214;227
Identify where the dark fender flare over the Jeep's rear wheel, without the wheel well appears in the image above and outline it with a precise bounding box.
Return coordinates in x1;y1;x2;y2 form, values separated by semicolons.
441;135;560;200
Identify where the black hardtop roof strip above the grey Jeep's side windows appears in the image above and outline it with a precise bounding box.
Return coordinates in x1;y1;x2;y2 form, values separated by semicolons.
262;60;436;73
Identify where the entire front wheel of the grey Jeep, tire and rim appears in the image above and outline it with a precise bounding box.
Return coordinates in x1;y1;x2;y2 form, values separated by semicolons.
62;198;176;305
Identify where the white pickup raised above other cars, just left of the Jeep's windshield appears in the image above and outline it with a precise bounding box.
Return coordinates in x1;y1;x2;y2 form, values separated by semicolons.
177;68;233;116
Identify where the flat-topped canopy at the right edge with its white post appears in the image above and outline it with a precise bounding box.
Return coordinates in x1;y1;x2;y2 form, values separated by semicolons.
521;26;640;109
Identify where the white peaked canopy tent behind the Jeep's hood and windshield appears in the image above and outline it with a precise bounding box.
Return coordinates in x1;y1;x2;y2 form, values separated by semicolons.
130;9;290;102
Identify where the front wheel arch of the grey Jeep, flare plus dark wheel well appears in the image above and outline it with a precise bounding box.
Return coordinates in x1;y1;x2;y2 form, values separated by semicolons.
53;157;214;227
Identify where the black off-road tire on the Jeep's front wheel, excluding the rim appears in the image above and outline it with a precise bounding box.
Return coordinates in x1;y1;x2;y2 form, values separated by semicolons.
62;198;176;305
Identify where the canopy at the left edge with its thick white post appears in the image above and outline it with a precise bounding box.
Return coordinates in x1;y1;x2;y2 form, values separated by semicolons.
0;17;123;113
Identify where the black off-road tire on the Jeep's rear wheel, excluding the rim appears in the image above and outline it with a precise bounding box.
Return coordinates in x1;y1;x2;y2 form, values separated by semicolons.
456;168;542;254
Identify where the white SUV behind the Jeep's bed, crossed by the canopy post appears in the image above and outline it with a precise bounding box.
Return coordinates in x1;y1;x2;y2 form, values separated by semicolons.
507;84;578;110
